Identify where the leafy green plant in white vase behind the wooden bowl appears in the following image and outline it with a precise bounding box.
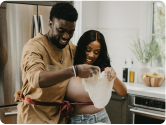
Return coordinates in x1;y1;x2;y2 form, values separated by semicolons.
130;37;159;83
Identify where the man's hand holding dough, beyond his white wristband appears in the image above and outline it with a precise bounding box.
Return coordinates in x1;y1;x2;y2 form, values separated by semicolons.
77;64;100;78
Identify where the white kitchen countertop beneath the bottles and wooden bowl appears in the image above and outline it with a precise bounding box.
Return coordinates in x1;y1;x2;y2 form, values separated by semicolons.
125;83;166;100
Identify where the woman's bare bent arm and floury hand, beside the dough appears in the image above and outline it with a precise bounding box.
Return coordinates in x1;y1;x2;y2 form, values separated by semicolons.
105;67;127;96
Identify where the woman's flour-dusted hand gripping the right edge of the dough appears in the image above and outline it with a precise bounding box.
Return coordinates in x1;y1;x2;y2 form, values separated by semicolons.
104;67;116;81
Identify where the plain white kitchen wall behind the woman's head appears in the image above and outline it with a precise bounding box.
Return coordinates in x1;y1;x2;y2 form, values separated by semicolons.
81;0;151;80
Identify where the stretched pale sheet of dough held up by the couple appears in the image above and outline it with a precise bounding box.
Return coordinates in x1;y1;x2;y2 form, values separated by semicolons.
82;71;114;108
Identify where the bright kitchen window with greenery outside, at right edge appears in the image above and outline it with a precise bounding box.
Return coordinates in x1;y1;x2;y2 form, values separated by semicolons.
151;1;166;67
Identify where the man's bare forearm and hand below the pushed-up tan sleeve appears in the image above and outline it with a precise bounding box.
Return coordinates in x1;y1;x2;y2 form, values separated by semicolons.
39;64;99;88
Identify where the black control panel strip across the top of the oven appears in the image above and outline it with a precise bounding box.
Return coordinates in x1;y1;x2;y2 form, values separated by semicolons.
135;97;166;109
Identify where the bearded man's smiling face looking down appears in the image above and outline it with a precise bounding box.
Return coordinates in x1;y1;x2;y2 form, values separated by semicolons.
50;18;75;49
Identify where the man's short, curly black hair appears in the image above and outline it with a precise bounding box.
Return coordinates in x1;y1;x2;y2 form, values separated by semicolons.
50;3;78;22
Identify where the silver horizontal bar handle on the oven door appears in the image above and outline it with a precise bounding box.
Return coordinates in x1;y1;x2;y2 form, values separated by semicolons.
130;107;166;120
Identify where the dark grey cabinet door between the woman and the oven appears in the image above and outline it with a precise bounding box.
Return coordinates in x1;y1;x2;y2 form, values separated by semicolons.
106;92;128;124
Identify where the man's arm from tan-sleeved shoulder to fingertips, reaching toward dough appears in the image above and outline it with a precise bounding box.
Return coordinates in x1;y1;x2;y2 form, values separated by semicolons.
21;43;98;88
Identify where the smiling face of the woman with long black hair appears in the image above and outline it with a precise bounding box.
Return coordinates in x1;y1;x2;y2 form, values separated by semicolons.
84;40;101;65
